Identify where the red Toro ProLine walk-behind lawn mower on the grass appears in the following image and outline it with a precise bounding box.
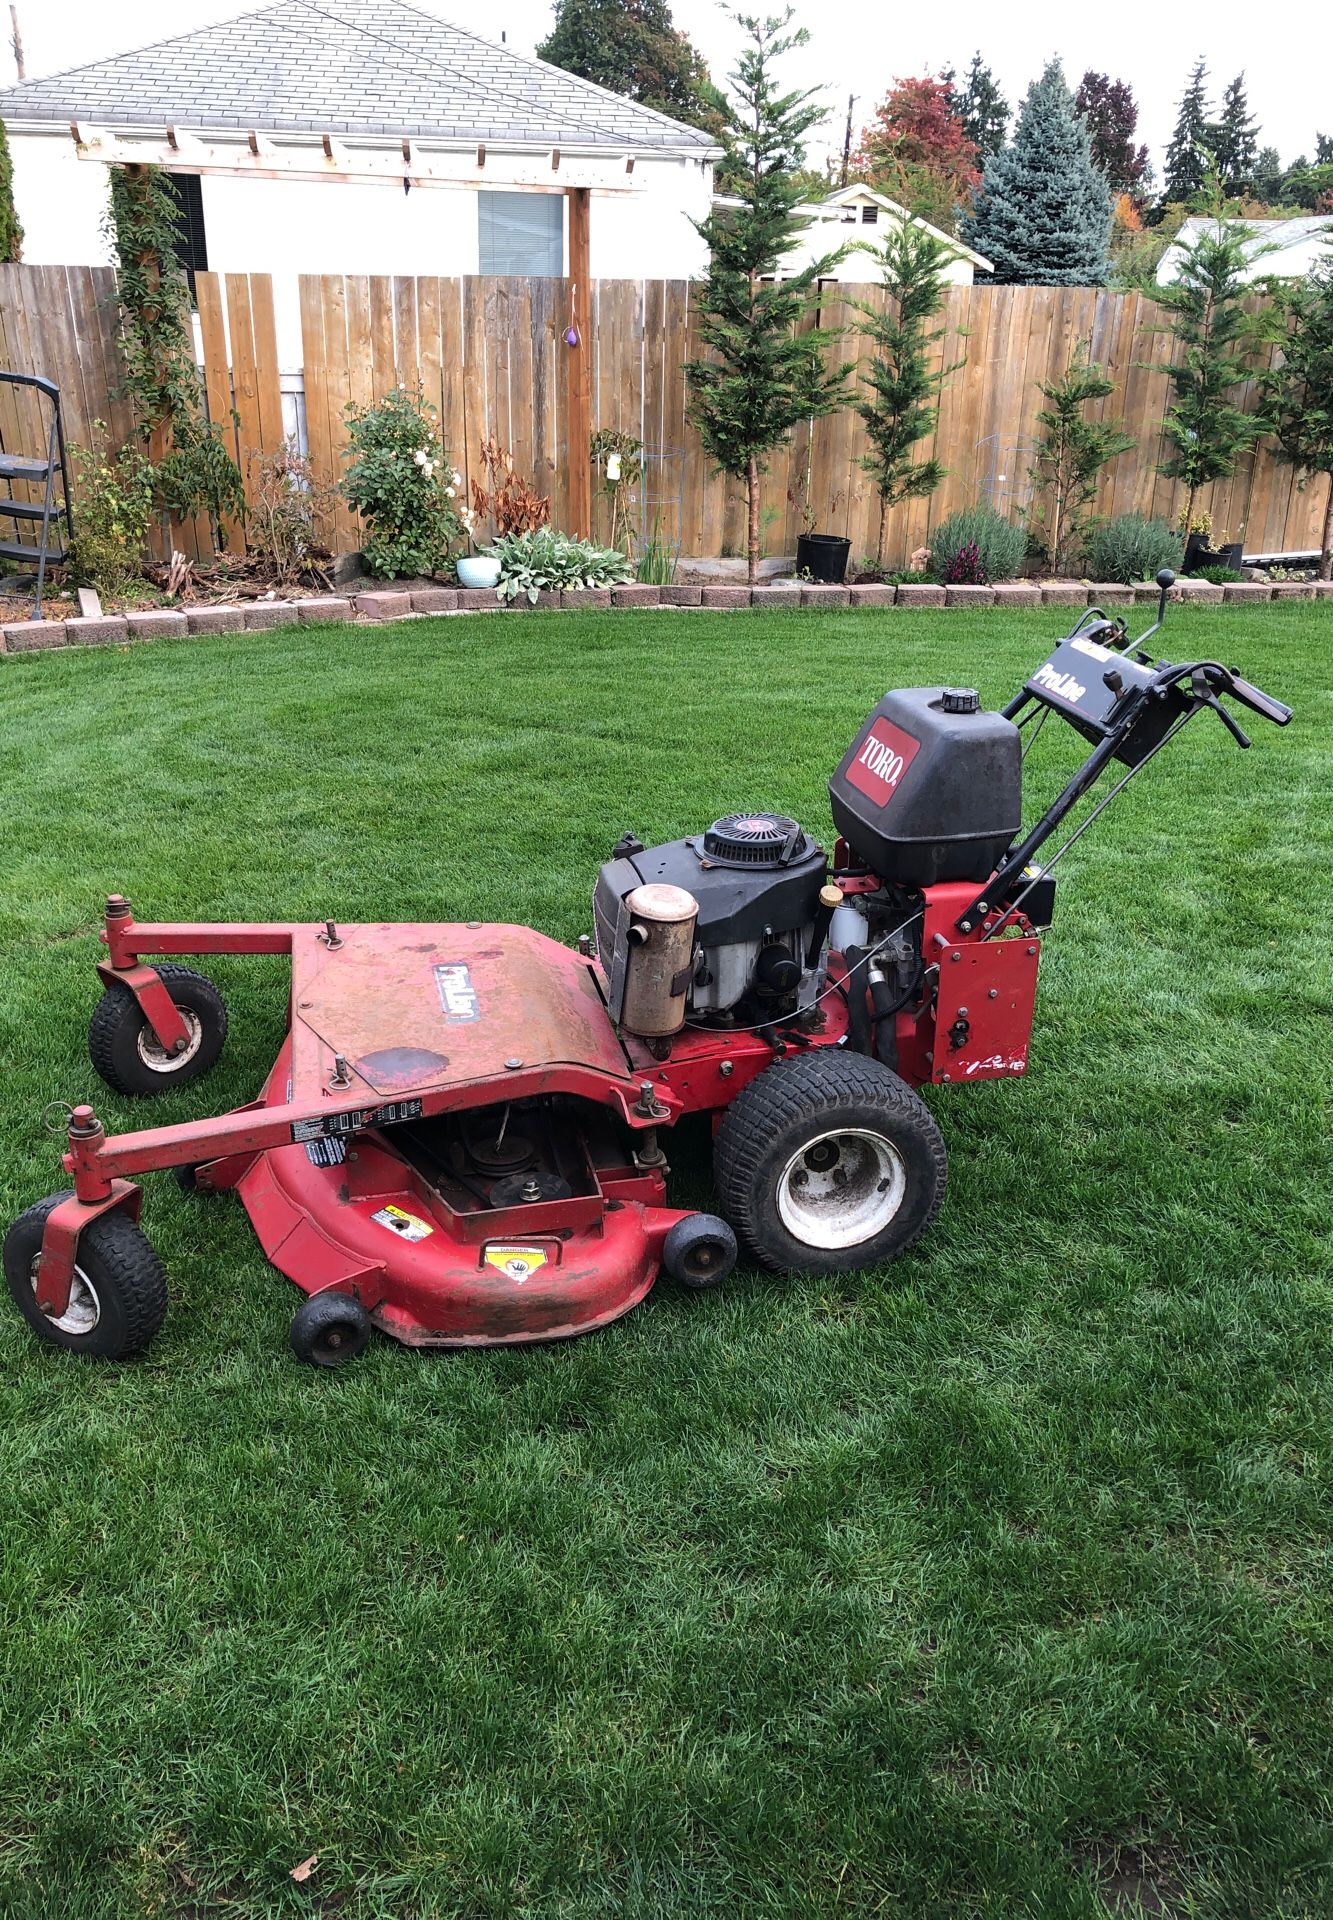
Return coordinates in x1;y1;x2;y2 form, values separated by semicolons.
4;572;1291;1365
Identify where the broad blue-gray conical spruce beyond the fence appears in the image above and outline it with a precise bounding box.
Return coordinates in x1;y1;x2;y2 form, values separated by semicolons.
962;60;1110;286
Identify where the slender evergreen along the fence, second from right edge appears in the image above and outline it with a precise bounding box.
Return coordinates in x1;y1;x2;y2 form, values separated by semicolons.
1156;197;1264;528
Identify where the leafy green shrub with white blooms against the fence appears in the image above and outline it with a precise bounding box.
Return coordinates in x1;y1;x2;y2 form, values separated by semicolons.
342;388;471;580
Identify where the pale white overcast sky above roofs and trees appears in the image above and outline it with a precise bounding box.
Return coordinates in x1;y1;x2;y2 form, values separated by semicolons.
0;0;1333;175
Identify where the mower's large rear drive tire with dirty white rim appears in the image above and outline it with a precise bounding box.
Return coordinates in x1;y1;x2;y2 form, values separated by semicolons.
713;1048;949;1273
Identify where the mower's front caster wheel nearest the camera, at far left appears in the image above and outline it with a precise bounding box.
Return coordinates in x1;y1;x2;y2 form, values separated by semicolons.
4;1194;167;1359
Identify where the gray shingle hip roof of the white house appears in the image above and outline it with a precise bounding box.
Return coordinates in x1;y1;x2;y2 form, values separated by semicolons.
0;0;715;154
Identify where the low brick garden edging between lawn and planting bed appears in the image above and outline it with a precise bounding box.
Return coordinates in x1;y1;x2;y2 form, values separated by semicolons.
0;580;1333;653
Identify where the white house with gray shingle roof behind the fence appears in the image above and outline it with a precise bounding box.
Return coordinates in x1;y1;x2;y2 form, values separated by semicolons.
0;0;720;363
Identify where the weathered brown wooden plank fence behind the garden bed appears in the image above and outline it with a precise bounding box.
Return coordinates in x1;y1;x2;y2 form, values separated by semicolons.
0;267;1321;563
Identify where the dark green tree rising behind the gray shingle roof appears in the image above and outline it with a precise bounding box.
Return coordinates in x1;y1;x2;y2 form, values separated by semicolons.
538;0;726;134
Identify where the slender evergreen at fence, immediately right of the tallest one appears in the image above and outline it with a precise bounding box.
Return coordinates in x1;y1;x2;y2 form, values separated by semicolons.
853;221;962;566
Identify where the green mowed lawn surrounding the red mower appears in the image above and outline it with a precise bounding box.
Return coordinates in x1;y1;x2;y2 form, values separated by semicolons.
0;605;1333;1920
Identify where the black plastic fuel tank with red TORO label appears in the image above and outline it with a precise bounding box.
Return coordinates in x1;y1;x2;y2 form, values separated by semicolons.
828;687;1022;887
